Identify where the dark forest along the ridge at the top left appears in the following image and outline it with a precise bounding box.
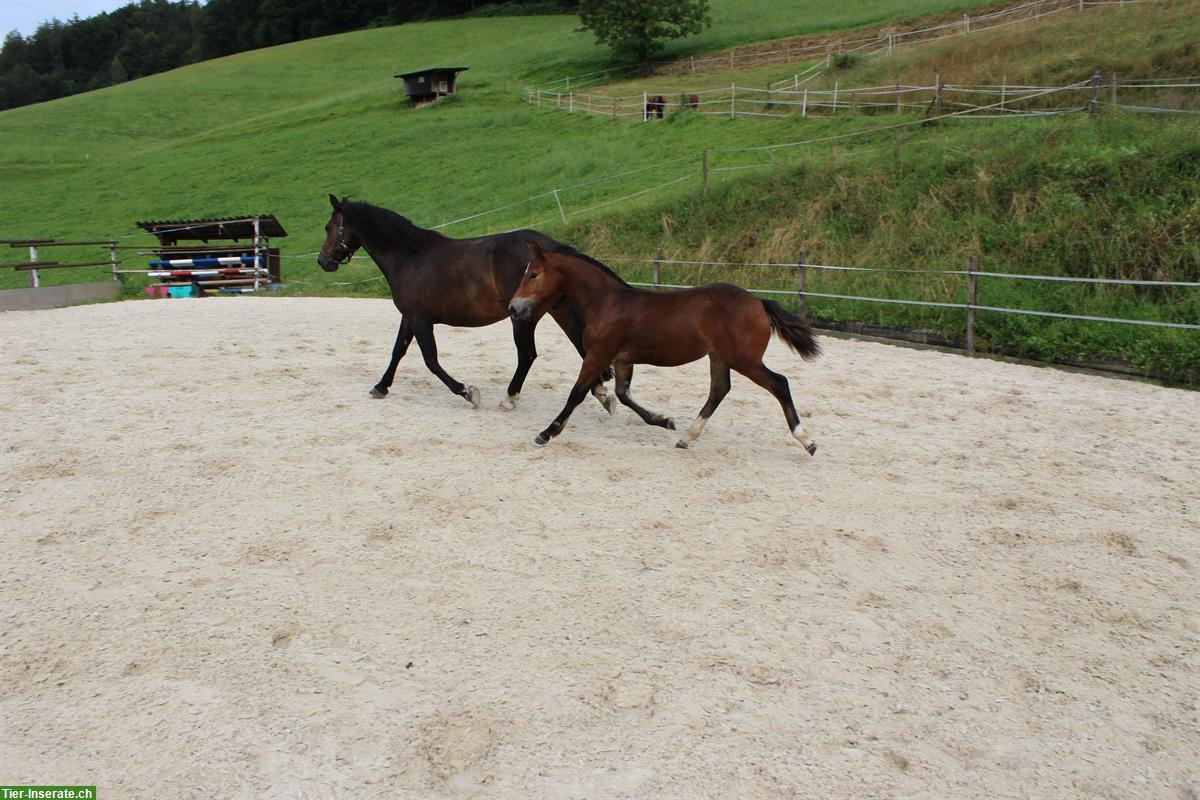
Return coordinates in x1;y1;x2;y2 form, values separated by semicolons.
0;0;578;109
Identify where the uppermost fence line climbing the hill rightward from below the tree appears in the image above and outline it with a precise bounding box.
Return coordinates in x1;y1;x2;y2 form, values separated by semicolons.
538;0;1157;94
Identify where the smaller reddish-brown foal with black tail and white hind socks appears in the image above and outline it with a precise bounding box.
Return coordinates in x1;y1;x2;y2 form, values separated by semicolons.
509;241;821;456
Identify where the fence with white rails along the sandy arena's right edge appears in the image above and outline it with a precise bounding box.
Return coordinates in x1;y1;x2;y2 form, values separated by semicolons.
601;253;1200;355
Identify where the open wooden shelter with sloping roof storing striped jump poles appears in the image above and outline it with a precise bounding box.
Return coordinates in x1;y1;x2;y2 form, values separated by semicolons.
137;213;288;294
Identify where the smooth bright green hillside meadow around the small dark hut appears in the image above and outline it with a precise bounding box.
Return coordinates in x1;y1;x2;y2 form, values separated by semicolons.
0;0;1008;287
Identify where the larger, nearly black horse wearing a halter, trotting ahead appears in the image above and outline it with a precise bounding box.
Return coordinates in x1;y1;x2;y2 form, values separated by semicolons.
317;194;616;414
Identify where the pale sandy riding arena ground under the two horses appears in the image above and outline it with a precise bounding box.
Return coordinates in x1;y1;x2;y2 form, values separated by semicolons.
0;299;1200;800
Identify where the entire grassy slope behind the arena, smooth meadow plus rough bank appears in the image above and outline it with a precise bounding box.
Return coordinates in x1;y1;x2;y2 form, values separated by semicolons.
0;0;1200;377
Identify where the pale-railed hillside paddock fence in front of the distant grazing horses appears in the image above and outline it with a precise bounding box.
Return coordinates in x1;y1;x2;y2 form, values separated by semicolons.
524;73;1200;121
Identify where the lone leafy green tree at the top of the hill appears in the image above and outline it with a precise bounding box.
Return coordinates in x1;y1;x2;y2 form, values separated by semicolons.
580;0;713;61
